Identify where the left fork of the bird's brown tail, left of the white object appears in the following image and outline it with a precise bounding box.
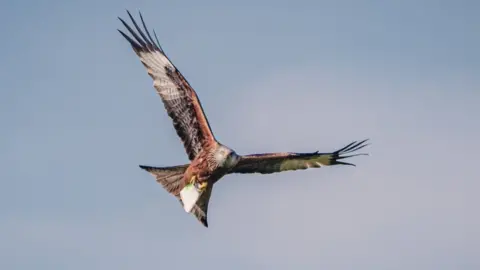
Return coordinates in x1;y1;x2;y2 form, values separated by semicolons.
139;164;188;195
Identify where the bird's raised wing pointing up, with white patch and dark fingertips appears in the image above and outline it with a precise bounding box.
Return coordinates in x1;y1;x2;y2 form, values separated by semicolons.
118;11;215;160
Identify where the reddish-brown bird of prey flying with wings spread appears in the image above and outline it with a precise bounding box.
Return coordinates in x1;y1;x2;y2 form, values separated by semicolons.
118;10;368;227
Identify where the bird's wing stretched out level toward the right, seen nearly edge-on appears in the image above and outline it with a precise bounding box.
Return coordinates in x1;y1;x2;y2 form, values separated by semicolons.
229;140;368;174
